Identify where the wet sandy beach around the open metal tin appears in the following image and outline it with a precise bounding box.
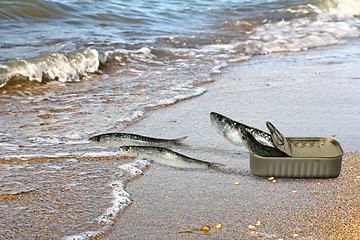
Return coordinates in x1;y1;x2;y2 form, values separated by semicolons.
104;41;360;239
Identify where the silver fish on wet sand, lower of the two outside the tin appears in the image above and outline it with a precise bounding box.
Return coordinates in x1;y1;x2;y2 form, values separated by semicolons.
119;146;225;170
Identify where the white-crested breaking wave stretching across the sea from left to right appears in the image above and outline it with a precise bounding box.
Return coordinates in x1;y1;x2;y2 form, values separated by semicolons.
0;0;360;87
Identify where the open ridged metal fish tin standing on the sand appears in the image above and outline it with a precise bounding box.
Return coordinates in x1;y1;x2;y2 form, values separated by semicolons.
250;138;343;178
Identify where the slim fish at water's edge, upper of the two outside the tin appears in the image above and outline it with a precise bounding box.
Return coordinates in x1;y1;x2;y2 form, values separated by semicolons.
89;133;187;148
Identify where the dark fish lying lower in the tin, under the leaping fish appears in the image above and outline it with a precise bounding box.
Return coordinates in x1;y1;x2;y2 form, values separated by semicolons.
240;126;289;157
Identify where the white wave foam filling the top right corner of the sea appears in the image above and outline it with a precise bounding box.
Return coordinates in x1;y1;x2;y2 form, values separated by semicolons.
224;0;360;57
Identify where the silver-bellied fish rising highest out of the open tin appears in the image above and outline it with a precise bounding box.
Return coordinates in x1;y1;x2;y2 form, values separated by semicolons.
210;112;274;147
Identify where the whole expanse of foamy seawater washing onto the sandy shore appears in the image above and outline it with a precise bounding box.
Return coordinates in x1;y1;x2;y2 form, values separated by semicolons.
0;0;360;239
